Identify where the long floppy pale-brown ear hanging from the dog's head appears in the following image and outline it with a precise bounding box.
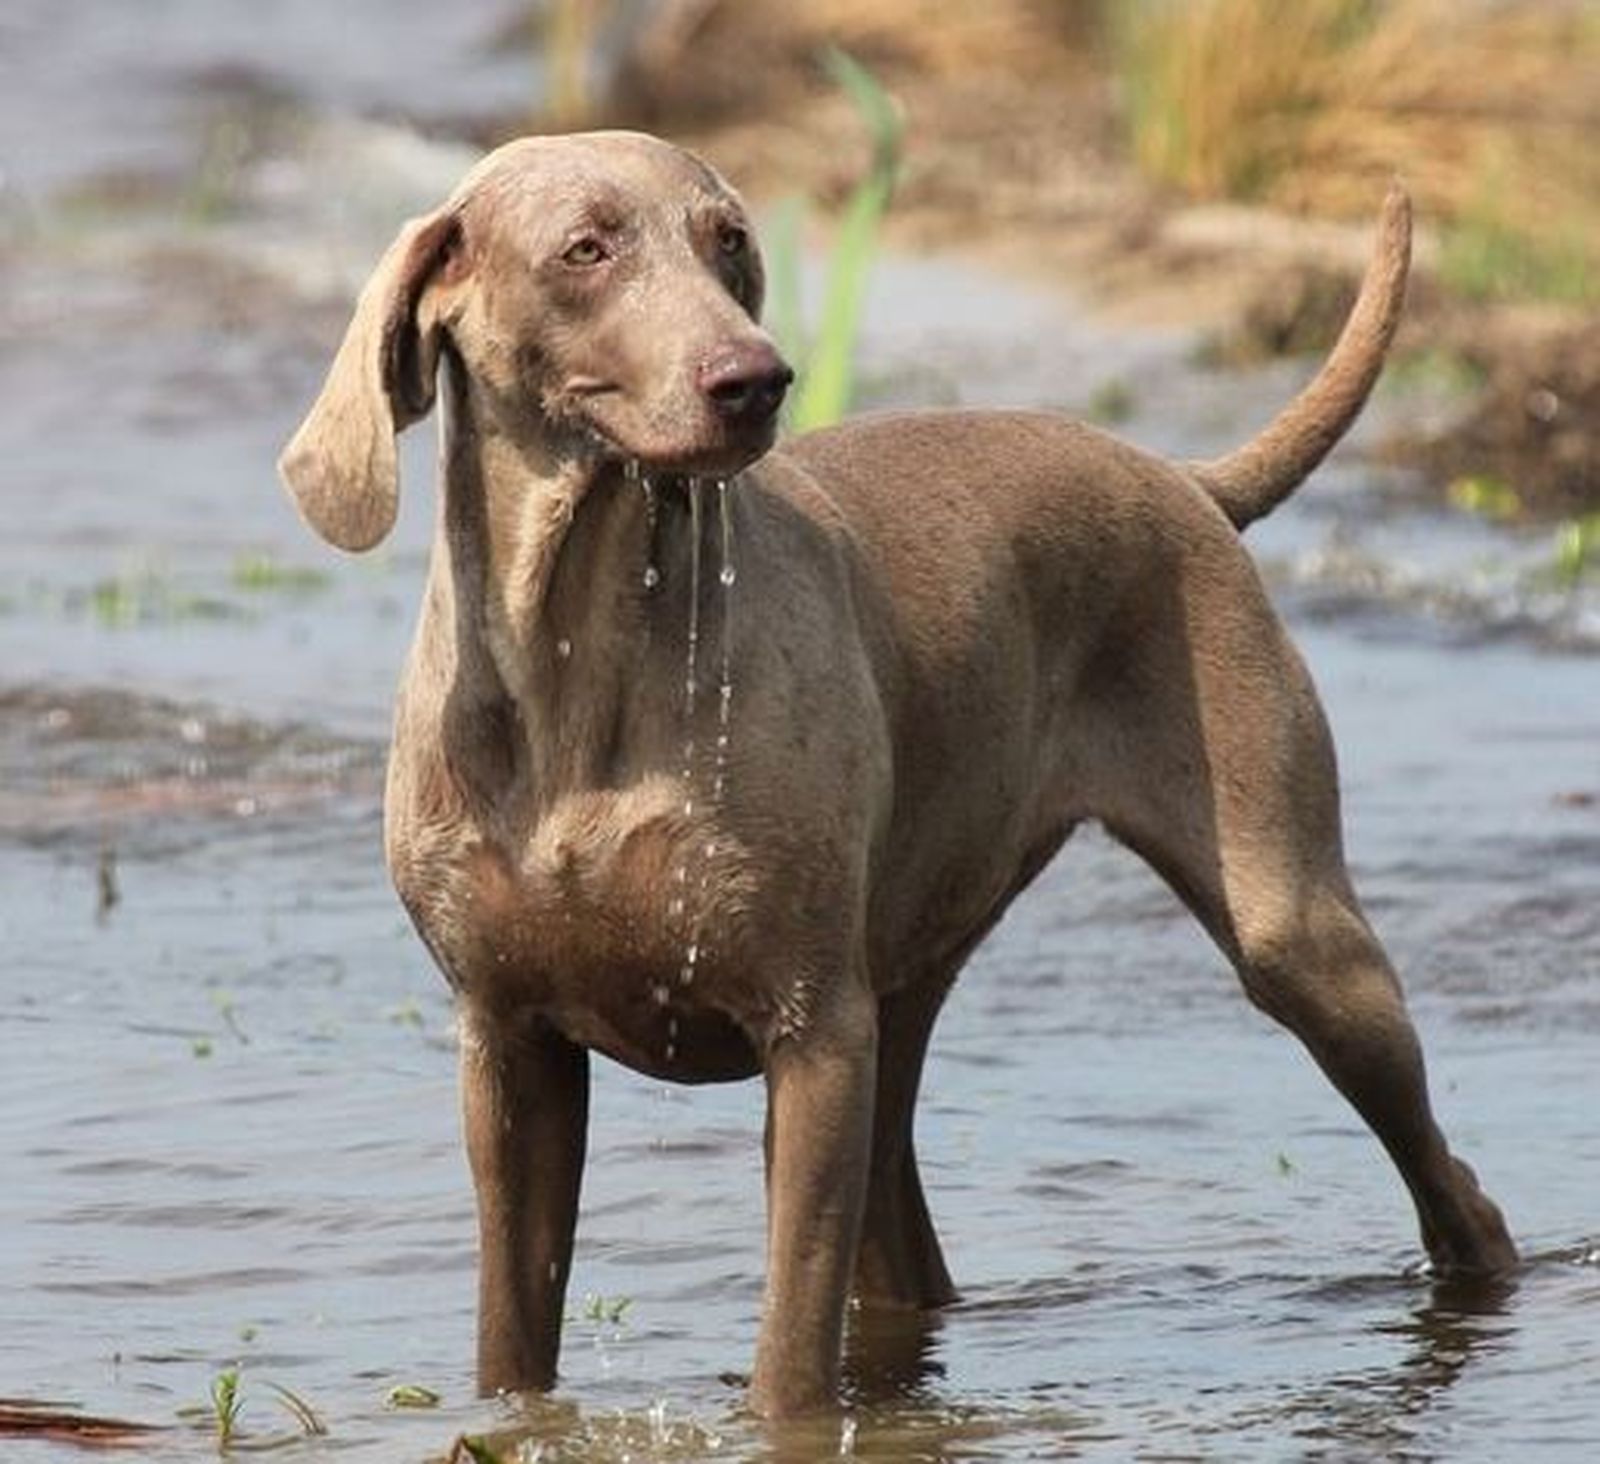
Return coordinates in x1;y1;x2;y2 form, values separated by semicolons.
278;213;461;550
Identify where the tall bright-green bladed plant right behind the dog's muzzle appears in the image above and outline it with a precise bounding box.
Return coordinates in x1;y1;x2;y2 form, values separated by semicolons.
768;50;902;432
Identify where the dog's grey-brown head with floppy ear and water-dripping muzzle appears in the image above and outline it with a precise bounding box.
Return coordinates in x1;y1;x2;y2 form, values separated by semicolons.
278;133;790;549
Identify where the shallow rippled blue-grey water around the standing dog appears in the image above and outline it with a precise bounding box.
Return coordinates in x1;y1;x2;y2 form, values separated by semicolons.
0;3;1600;1461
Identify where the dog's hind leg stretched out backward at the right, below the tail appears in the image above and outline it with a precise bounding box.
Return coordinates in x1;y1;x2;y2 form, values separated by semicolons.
1099;579;1517;1275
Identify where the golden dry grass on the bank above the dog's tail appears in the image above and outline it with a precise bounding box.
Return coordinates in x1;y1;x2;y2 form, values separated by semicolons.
1115;0;1600;296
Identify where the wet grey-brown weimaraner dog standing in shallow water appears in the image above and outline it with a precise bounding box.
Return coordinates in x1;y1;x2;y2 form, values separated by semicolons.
280;133;1515;1416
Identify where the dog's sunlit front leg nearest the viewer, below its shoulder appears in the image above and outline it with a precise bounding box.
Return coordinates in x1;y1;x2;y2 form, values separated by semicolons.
750;981;877;1418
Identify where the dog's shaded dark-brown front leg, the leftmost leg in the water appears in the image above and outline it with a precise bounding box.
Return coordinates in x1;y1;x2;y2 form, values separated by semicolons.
461;1011;589;1394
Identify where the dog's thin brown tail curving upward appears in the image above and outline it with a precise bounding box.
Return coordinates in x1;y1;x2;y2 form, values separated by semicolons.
1187;182;1411;528
